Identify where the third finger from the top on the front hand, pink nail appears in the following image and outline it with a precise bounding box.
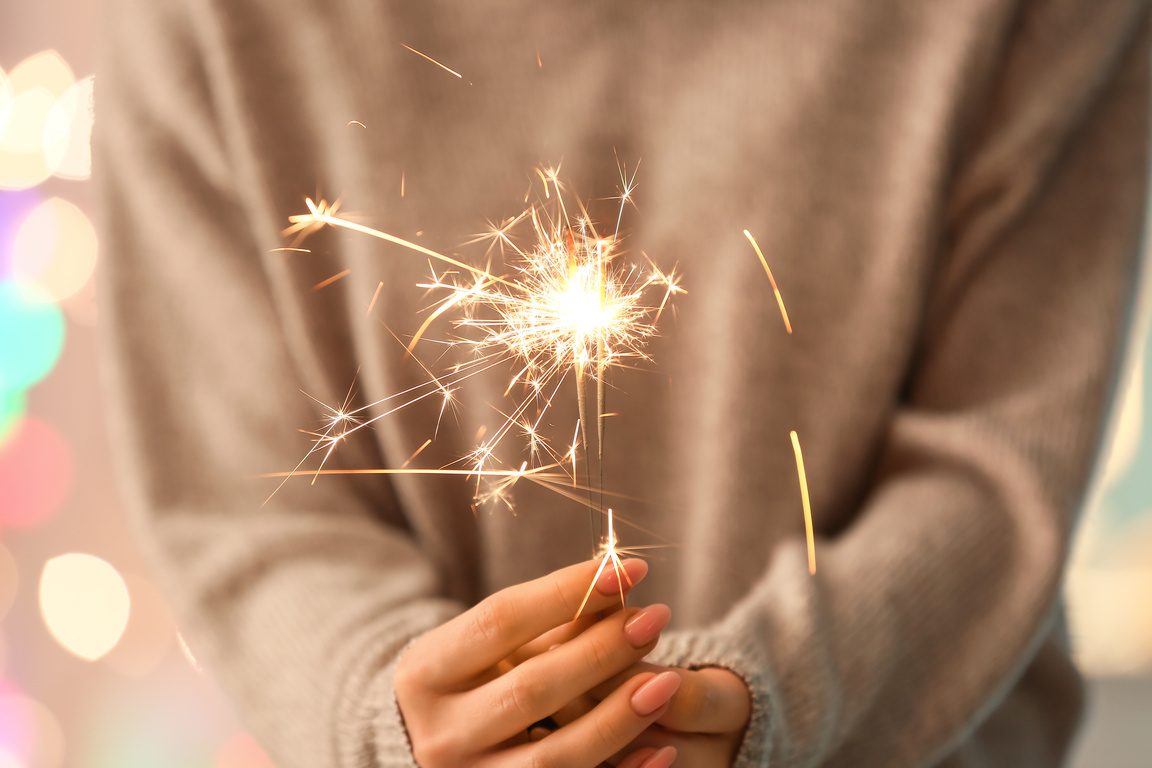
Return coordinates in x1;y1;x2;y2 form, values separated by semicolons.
480;674;675;768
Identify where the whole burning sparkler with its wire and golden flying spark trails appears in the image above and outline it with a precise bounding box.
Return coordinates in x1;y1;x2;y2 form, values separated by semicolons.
268;166;816;617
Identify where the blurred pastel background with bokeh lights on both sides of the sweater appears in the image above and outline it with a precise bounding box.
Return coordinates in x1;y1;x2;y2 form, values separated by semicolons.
0;0;1152;768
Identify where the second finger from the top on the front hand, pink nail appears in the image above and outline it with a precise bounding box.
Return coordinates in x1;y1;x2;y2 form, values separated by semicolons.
464;604;674;740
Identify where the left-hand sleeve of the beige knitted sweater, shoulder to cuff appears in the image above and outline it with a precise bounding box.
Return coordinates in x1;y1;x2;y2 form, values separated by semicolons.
94;1;461;768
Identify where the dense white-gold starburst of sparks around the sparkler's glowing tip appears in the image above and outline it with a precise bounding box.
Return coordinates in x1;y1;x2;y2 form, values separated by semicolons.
283;168;683;511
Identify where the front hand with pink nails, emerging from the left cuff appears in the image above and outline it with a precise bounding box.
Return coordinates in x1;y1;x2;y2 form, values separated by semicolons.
394;561;680;768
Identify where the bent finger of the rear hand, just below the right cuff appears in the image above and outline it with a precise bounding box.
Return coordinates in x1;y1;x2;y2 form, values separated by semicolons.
589;662;752;733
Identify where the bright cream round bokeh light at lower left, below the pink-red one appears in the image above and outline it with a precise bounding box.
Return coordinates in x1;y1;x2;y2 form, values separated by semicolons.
40;554;130;661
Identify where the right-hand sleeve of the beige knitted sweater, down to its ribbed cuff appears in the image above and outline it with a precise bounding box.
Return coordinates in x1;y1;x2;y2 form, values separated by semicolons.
655;2;1150;768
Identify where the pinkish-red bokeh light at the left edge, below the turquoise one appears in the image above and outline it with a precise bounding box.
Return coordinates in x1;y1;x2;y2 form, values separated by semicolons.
0;417;73;530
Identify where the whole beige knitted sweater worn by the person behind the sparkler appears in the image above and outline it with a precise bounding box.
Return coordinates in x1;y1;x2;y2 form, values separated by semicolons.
96;0;1150;768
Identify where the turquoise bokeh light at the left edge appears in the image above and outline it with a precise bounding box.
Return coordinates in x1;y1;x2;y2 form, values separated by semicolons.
0;280;65;391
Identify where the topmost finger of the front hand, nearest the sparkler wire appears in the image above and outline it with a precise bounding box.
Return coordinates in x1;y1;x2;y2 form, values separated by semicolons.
417;560;647;689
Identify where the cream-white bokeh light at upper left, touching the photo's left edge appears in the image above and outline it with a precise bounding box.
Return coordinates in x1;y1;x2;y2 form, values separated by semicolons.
0;51;75;189
